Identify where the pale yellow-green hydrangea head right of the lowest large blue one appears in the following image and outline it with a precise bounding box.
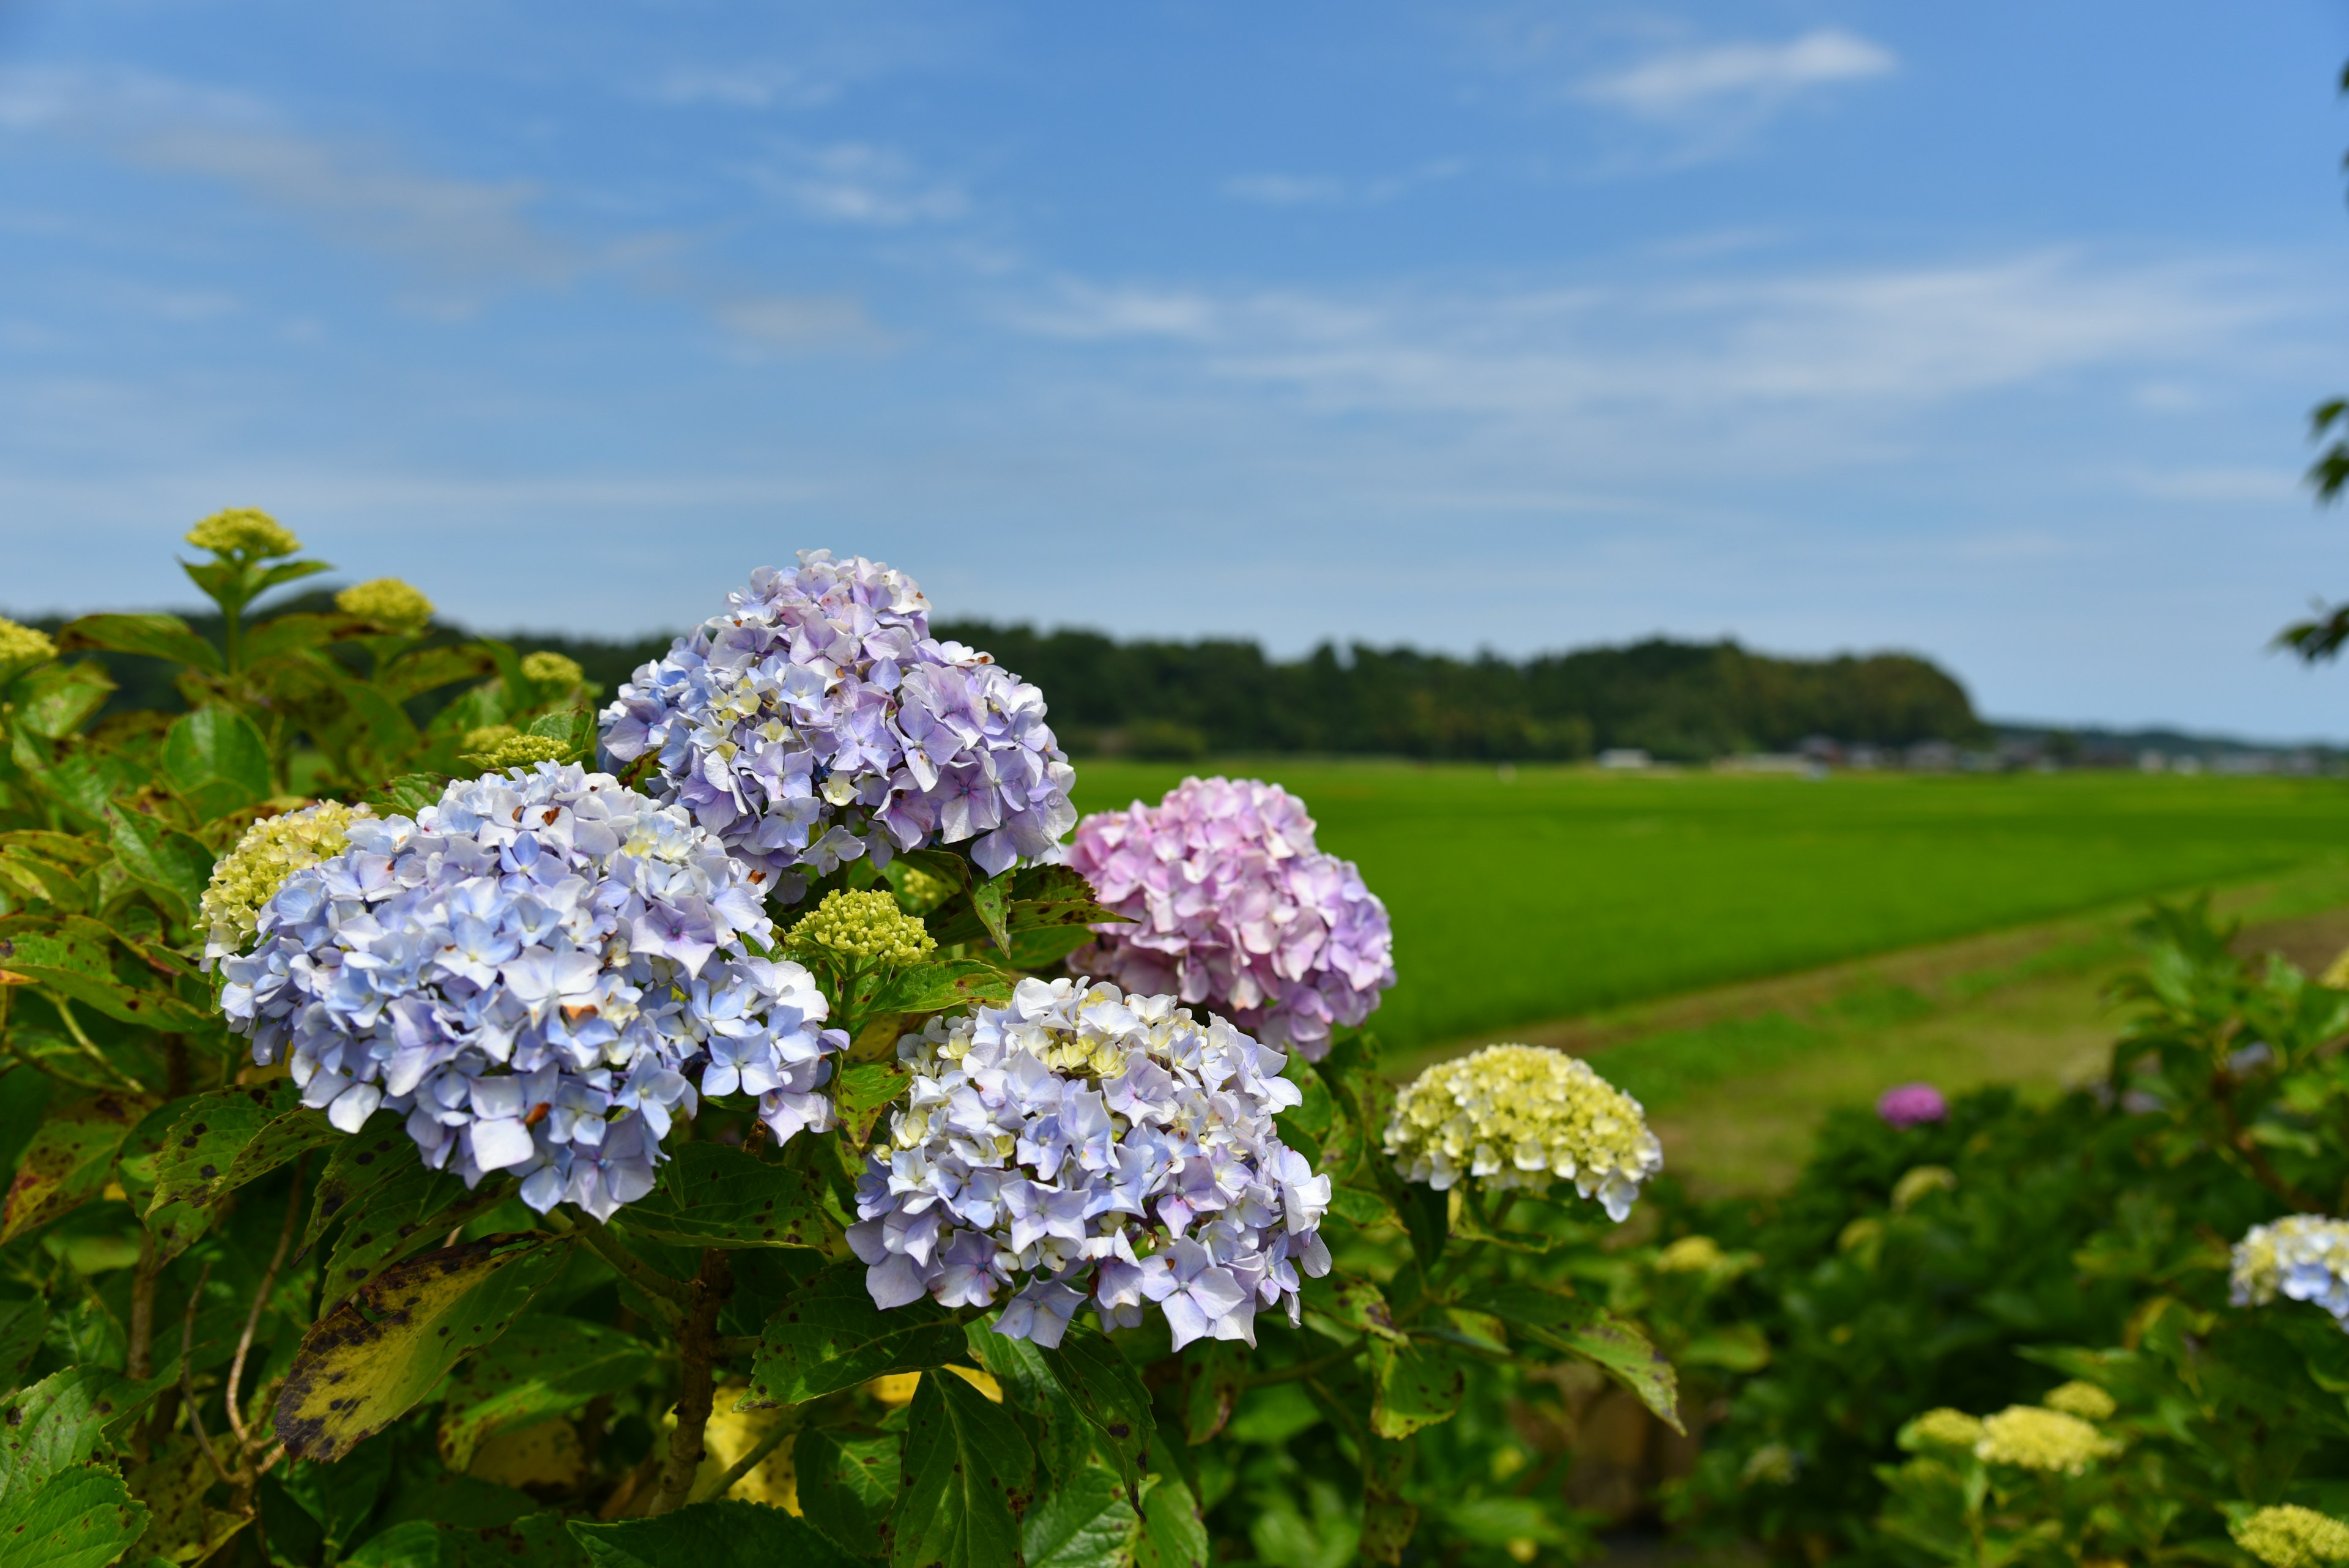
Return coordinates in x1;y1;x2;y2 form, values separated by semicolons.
1386;1046;1663;1222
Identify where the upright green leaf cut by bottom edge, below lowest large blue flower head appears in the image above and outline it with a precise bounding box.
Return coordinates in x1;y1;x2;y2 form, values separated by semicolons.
888;1363;1036;1568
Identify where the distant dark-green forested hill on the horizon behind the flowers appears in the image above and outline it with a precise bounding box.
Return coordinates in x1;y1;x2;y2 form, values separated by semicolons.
40;595;1989;762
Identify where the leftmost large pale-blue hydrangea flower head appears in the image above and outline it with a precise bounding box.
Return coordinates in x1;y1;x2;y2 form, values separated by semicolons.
221;762;848;1220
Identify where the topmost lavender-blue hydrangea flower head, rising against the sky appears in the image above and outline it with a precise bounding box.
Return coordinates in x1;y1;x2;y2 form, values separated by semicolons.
604;550;1076;901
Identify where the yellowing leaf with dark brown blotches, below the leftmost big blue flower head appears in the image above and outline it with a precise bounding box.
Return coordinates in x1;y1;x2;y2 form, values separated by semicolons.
277;1232;571;1460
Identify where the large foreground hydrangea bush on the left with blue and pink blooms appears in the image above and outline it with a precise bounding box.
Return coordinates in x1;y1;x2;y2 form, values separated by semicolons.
0;524;1691;1568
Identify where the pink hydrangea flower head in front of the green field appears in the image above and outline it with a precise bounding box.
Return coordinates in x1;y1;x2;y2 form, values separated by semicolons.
1069;778;1395;1063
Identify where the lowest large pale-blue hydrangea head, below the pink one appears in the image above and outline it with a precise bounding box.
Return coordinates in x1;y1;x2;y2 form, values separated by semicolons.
848;978;1329;1350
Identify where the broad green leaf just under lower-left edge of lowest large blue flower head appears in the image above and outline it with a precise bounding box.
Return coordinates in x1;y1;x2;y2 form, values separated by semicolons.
742;1258;965;1411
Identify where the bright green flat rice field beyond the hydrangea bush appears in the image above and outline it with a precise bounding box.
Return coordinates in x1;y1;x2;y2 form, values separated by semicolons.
1076;757;2349;1049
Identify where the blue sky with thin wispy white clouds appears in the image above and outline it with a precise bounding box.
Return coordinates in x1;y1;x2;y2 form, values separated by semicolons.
0;0;2349;738
